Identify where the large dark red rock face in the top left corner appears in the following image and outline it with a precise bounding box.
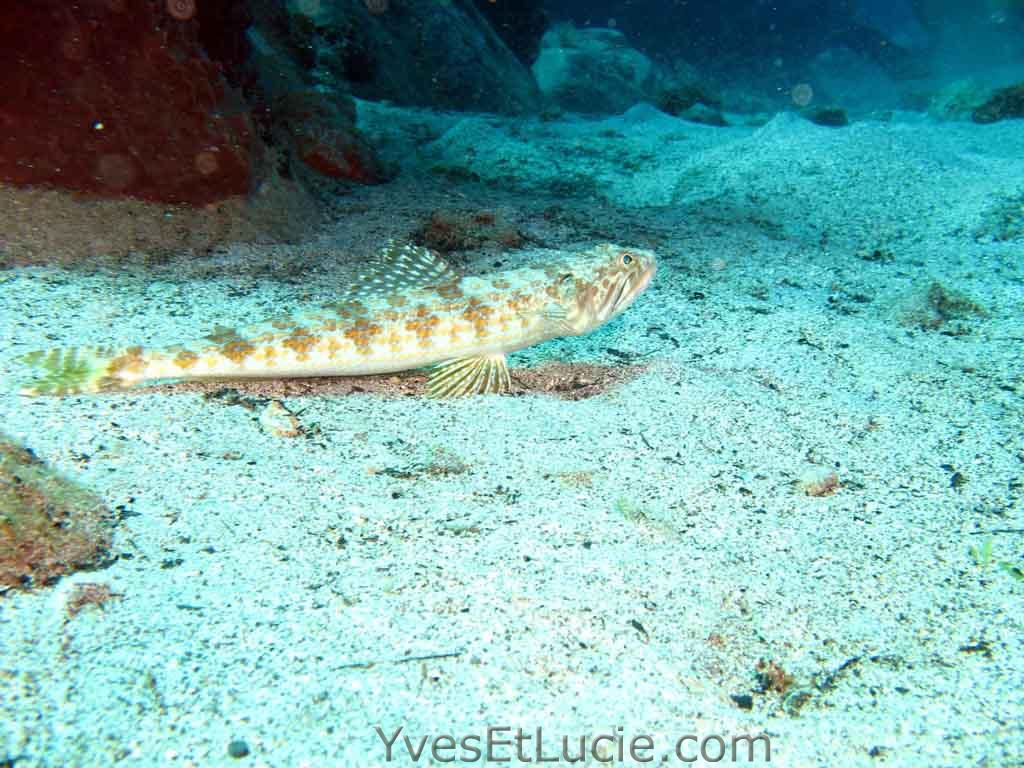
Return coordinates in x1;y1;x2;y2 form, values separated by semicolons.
0;0;251;205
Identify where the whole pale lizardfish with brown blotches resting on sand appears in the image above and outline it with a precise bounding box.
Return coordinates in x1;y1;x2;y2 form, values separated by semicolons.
22;244;655;397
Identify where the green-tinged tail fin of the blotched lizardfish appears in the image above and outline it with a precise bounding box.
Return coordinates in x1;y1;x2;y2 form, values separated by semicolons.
19;347;141;395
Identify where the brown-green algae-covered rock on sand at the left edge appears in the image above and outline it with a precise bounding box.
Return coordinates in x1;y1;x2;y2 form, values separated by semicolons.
0;433;113;594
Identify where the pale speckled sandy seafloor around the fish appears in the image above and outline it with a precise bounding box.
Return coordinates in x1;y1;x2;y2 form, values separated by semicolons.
0;108;1024;768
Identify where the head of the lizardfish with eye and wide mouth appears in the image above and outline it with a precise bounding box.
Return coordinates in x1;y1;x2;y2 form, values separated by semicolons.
559;245;657;334
